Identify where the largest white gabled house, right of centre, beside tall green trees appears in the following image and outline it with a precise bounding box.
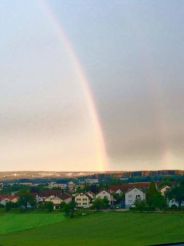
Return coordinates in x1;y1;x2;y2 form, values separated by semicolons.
125;188;146;208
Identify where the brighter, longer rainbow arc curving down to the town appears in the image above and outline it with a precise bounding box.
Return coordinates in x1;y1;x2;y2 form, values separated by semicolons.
39;0;108;171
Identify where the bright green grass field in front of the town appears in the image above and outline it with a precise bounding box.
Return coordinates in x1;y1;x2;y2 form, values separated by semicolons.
0;212;184;246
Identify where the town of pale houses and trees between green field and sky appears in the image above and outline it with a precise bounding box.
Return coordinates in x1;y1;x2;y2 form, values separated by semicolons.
0;171;184;213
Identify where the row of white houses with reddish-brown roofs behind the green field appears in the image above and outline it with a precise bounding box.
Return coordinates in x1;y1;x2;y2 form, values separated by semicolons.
0;183;178;209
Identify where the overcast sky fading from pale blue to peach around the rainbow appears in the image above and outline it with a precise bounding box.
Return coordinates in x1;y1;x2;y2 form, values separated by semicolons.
0;0;184;171
